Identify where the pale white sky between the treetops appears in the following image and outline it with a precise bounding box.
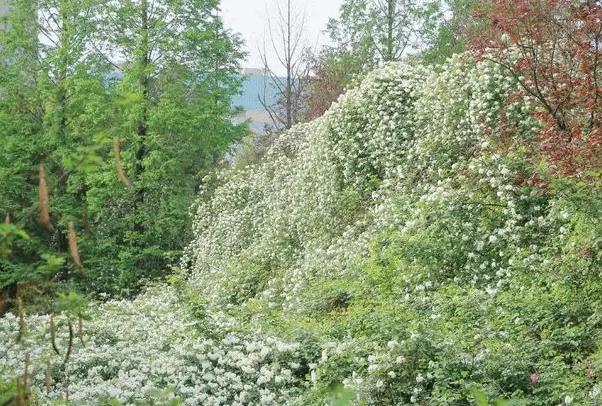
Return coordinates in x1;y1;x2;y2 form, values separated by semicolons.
222;0;342;73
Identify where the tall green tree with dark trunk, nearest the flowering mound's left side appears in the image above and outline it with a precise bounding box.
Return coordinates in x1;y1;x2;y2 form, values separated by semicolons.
82;0;246;291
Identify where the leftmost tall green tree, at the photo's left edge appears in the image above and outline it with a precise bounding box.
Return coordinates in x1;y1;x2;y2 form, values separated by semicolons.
0;0;107;308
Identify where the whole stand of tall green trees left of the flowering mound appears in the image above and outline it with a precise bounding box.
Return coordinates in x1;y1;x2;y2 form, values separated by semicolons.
0;0;247;302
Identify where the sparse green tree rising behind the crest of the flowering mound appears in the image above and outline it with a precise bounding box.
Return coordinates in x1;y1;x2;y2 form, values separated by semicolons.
327;0;476;68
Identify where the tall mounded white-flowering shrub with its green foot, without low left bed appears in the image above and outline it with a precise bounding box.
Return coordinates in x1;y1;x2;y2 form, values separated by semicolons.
185;52;600;405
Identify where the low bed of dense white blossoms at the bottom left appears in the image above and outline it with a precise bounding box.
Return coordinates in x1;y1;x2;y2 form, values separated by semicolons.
0;287;301;405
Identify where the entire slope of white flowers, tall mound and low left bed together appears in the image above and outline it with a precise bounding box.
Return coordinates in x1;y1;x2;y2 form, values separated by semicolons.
0;56;602;405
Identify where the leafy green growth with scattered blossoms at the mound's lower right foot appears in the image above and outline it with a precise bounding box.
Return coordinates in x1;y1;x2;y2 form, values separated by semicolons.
288;194;602;405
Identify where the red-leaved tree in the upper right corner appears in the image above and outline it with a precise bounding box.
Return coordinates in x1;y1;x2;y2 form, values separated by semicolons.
470;0;602;176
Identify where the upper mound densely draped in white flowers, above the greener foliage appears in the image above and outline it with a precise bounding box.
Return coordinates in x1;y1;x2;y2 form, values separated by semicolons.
184;58;541;307
